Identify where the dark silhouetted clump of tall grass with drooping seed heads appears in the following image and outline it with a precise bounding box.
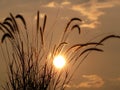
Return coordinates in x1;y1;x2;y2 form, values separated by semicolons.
0;11;120;90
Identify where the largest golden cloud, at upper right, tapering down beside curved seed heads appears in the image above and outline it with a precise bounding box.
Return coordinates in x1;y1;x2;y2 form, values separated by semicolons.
71;0;120;28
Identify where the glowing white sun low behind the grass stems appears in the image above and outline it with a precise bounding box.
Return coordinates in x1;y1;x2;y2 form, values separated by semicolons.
53;55;66;69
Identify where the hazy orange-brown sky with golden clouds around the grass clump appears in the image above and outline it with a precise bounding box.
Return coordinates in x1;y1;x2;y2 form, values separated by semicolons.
0;0;120;90
